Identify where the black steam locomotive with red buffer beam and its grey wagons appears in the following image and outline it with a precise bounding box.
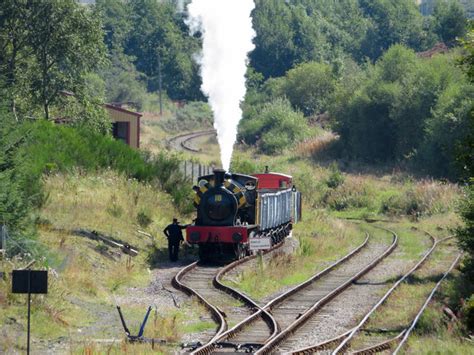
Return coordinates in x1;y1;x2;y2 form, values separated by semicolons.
186;168;301;260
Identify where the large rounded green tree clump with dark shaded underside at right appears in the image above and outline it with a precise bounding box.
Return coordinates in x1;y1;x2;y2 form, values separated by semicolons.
331;45;474;174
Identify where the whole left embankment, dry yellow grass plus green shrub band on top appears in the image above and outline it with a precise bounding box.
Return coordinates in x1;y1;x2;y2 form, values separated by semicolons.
0;118;218;352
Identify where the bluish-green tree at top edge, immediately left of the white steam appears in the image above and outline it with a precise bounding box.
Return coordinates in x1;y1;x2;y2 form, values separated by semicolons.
125;0;203;99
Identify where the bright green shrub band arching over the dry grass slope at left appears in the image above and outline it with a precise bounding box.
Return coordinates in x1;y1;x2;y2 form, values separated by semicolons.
0;119;192;254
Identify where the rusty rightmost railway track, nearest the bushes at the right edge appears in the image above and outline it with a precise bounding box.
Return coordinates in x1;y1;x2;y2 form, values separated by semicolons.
289;236;459;354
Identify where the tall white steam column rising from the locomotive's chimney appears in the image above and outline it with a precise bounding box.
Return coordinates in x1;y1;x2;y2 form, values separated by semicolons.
187;0;255;170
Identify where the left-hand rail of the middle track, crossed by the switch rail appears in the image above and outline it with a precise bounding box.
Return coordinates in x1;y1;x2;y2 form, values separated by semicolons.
194;233;369;349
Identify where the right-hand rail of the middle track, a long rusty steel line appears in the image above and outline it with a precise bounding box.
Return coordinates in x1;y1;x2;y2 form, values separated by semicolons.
255;230;398;354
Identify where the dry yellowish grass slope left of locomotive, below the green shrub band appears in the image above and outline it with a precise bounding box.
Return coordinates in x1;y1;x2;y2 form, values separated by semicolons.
0;171;214;351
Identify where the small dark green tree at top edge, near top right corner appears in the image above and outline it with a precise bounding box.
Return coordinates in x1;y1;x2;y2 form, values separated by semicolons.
433;0;468;43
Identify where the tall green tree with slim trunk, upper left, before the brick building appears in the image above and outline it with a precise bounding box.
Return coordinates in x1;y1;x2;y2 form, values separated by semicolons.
28;0;106;119
